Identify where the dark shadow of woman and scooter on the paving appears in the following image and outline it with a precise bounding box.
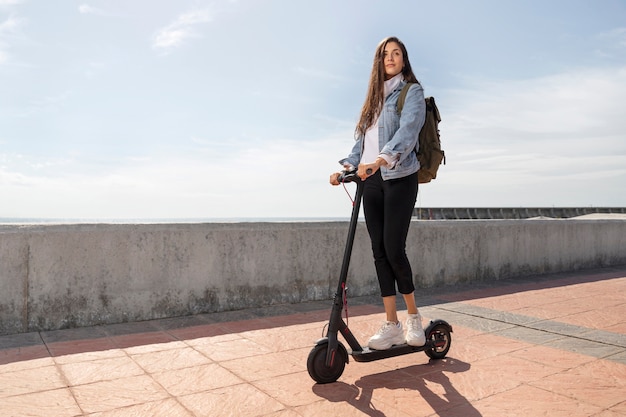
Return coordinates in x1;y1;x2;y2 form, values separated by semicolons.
313;357;481;417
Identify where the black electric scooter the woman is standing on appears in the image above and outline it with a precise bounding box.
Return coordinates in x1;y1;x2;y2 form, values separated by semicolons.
307;170;452;384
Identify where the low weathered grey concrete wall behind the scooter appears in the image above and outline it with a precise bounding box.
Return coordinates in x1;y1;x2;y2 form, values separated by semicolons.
0;220;626;334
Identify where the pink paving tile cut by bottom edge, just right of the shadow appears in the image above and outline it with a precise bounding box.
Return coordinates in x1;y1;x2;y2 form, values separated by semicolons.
474;385;602;417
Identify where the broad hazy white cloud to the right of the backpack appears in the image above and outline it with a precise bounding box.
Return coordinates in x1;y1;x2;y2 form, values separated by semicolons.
422;68;626;206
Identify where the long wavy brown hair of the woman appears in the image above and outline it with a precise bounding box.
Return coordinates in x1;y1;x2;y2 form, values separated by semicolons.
354;36;419;137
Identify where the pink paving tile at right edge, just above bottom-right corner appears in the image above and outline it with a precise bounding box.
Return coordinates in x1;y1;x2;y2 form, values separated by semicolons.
531;360;626;408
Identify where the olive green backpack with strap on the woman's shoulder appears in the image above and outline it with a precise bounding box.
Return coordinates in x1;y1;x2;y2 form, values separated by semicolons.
397;83;446;184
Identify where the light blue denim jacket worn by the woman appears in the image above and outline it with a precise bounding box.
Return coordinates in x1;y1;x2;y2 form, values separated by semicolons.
339;81;426;180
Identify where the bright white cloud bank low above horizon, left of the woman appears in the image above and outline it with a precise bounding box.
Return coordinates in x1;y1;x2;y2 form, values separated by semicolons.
0;134;350;219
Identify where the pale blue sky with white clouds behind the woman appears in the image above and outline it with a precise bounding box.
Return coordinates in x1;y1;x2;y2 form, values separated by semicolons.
0;0;626;221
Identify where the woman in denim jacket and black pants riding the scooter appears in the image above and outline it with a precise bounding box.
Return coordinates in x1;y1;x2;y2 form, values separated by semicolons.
330;37;426;350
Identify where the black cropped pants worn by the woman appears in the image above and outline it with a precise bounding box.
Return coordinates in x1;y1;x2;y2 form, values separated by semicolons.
363;171;418;297
